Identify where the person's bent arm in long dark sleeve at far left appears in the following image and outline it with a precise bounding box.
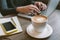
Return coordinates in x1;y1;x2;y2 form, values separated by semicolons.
0;0;17;15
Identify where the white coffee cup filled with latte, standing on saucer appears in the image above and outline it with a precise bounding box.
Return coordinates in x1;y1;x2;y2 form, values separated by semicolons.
31;15;48;32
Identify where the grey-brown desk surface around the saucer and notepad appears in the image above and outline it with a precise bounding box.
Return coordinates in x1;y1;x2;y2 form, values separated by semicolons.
0;10;60;40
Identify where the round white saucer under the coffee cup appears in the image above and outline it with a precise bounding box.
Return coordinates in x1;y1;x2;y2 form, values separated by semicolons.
27;24;53;38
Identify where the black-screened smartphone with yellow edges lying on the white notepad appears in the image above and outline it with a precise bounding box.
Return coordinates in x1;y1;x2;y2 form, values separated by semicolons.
1;22;17;34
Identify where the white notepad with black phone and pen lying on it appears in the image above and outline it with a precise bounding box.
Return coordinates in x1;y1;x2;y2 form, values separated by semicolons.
0;16;22;36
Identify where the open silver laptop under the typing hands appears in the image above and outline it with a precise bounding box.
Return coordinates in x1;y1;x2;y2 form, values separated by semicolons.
18;0;60;18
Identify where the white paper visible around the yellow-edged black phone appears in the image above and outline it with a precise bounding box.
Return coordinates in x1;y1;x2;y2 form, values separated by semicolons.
0;16;22;36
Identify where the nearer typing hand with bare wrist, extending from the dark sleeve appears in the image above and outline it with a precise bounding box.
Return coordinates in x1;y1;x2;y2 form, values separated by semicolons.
16;4;40;13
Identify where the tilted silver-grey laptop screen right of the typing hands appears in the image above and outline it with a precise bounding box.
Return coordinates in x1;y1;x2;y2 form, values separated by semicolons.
44;0;60;16
